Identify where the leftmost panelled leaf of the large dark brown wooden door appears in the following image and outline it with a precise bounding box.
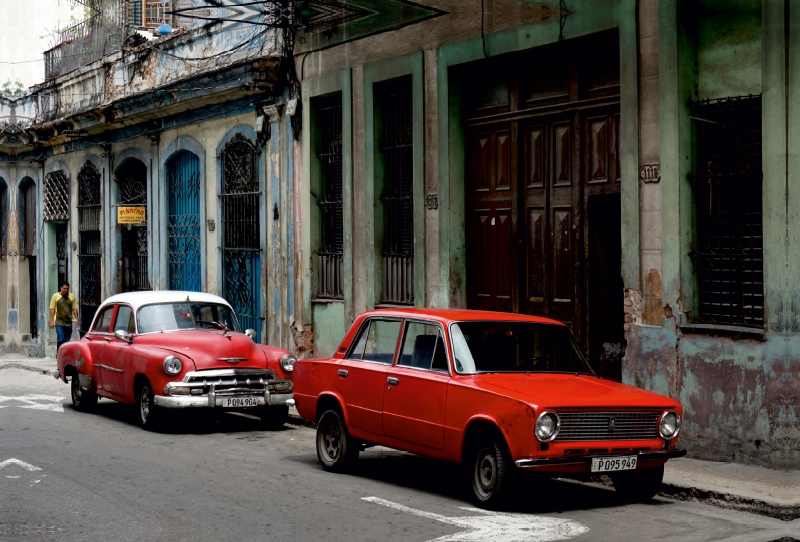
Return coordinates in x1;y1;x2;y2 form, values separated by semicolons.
467;125;518;312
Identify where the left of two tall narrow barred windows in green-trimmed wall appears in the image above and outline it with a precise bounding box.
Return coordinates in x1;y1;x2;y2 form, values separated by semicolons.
316;94;344;299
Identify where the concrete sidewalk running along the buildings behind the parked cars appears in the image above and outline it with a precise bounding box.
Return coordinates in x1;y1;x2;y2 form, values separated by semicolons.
0;354;800;521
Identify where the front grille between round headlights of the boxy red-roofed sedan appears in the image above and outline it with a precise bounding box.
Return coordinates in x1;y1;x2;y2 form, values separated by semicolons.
555;411;661;442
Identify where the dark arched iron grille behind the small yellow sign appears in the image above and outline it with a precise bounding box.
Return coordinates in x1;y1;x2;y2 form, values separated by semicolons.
116;159;152;292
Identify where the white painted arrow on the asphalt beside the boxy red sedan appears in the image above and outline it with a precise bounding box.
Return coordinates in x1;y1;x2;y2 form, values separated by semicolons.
362;497;589;542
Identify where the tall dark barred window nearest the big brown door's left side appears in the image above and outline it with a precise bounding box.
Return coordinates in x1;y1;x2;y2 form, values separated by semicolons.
380;77;414;305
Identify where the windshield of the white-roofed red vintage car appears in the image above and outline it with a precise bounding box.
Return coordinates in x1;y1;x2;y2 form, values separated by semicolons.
138;302;239;333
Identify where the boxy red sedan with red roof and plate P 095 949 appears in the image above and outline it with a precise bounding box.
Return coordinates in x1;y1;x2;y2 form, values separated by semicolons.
293;309;686;508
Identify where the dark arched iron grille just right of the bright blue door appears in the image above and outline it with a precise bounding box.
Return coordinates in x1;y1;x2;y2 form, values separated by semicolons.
220;134;264;340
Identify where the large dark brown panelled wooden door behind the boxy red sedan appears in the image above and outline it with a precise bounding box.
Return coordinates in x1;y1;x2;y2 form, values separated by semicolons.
466;104;624;379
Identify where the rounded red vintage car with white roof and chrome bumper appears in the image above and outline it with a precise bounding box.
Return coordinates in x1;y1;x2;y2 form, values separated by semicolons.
55;291;295;429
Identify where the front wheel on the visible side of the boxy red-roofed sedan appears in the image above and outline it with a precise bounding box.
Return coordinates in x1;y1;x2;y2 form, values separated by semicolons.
466;436;515;510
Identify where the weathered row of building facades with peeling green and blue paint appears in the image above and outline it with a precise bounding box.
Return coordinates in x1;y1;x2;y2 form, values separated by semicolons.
0;0;800;467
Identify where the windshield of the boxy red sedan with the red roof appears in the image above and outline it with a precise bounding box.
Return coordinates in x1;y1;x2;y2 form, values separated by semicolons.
450;322;594;374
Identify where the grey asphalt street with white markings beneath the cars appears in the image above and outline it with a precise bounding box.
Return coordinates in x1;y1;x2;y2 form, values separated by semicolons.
0;369;800;542
